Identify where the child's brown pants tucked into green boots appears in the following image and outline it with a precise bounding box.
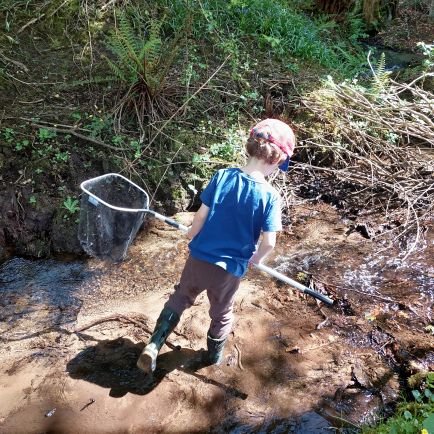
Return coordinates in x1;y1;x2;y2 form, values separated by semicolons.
165;256;240;339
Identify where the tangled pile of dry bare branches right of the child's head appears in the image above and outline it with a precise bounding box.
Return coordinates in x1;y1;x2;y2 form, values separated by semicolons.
296;74;434;257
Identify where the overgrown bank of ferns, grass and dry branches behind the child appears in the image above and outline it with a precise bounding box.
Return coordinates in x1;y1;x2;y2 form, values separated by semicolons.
0;0;434;264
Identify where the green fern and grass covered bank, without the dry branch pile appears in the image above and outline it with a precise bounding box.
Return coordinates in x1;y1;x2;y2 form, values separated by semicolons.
0;0;432;202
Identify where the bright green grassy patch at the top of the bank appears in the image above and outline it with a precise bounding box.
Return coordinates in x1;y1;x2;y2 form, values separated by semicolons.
154;0;366;76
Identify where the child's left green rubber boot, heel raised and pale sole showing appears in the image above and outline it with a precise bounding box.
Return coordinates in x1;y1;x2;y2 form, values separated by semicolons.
137;307;179;374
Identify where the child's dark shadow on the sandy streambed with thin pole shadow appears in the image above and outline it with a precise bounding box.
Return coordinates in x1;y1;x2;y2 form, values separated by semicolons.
66;338;247;399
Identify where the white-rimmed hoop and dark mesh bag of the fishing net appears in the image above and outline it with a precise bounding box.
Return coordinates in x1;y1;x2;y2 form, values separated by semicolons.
78;173;149;262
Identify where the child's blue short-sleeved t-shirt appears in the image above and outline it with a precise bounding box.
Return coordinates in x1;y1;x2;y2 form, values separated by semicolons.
189;169;282;277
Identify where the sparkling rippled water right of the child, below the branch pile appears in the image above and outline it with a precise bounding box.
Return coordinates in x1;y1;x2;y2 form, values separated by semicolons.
276;240;434;323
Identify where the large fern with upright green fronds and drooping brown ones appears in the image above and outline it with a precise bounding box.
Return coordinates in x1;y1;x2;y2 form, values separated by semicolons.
106;10;189;126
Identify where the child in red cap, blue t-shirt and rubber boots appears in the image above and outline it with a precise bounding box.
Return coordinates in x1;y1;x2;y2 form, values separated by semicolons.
137;119;295;373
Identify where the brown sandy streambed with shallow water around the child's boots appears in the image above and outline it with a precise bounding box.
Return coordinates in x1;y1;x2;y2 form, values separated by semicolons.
0;204;434;434
